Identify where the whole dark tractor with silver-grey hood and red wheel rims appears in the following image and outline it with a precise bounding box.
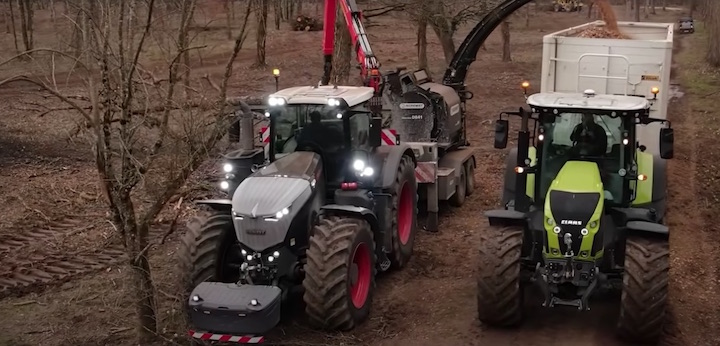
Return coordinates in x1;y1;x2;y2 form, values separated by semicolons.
179;86;417;341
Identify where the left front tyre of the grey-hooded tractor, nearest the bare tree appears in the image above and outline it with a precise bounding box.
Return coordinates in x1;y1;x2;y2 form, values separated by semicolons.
177;212;243;294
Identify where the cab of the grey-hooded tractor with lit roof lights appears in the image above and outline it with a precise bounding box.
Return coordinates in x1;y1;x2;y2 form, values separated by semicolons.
266;86;381;191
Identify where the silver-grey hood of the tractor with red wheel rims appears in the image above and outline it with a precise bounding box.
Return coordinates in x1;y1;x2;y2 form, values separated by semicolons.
232;152;322;251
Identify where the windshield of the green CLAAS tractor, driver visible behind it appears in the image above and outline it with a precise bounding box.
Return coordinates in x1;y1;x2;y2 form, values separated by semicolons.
540;112;625;204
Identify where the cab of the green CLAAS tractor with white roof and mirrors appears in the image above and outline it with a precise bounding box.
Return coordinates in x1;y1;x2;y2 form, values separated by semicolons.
495;90;672;207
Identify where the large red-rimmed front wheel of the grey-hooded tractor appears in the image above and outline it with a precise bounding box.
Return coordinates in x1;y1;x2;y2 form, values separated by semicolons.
303;216;377;331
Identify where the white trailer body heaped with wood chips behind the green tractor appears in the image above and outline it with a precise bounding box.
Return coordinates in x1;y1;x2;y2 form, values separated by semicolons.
540;21;674;154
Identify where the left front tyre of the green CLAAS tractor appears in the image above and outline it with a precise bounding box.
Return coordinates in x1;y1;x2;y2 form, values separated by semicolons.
477;226;523;327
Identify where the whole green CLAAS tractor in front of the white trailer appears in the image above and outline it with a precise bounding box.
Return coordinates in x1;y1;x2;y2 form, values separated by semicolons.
477;87;674;342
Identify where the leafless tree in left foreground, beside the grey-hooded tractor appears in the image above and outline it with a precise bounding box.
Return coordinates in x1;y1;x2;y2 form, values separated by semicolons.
0;0;250;344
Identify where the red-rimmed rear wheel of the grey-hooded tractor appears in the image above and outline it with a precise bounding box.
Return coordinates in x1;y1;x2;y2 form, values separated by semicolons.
389;156;418;269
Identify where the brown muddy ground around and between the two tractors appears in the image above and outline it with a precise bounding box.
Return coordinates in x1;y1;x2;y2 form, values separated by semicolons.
0;2;720;345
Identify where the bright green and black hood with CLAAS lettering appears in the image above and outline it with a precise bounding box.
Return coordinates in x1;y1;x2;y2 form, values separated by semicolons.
544;161;604;259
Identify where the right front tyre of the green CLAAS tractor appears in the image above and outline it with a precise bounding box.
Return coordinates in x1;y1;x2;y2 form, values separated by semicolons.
617;237;670;343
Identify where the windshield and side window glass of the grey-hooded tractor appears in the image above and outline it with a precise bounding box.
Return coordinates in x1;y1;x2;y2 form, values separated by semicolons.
273;104;370;157
